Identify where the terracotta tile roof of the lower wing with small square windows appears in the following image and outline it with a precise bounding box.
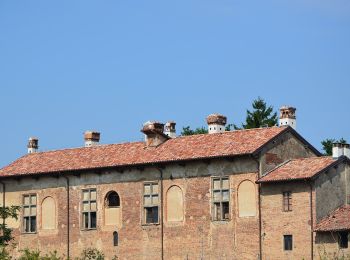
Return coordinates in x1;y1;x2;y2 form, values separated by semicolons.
257;156;337;183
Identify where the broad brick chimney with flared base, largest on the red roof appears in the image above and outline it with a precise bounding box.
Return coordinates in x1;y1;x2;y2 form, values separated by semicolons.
141;121;170;147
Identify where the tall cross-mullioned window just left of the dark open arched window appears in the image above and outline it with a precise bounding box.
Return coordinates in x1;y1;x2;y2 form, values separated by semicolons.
82;189;97;229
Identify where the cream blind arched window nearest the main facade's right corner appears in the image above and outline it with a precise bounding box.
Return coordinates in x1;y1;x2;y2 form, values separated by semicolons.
238;180;256;217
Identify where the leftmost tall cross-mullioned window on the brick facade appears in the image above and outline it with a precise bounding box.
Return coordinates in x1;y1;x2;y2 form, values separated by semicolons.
23;194;36;233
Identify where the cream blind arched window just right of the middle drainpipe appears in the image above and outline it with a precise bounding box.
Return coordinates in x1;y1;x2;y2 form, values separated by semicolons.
166;186;184;221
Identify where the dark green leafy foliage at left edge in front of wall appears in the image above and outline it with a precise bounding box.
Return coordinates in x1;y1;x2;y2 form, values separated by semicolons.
0;206;20;246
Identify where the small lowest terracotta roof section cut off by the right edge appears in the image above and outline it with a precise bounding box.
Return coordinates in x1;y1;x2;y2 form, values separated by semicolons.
315;205;350;232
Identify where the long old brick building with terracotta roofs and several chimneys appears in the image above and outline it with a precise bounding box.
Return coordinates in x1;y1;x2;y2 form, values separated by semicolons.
0;107;350;259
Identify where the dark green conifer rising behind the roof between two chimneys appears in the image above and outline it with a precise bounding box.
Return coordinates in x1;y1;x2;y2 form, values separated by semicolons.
237;97;277;129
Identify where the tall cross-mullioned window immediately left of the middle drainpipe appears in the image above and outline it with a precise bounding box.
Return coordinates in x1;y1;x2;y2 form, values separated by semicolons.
143;183;159;224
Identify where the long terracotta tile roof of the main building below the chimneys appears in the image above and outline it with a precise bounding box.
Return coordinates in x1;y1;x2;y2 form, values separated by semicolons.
0;127;288;177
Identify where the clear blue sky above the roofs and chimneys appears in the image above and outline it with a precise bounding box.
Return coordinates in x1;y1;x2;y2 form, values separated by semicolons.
0;0;350;166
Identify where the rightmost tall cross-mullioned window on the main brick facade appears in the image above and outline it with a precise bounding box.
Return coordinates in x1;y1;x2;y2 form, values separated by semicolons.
212;177;230;220
